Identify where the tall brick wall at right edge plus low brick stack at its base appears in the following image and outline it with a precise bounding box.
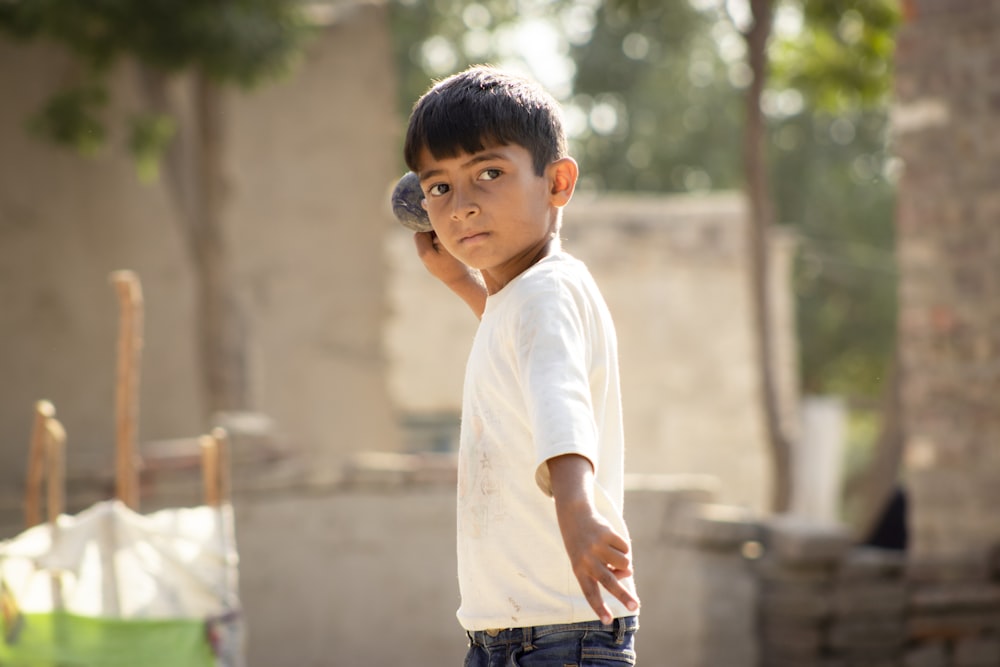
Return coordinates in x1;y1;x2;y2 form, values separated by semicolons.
756;0;1000;667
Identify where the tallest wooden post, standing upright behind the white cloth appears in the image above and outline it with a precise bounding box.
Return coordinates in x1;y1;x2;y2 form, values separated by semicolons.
111;271;143;510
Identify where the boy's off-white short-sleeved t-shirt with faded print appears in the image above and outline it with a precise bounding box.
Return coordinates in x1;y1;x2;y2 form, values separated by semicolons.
457;252;633;630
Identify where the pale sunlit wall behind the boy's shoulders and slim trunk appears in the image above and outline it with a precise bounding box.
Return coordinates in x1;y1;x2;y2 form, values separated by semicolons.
386;193;798;510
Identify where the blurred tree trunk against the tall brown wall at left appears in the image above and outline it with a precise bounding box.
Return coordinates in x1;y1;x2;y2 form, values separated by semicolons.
142;68;251;420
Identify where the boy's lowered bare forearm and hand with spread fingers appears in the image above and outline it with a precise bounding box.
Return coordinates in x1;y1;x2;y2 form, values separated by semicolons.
547;454;639;624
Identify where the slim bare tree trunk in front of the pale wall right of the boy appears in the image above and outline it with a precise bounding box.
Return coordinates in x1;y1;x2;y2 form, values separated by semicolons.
743;0;792;512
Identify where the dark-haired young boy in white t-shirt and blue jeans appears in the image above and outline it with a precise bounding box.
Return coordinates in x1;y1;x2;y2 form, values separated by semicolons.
404;66;639;667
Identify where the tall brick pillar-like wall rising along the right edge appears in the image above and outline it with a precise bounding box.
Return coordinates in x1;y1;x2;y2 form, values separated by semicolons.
892;0;1000;568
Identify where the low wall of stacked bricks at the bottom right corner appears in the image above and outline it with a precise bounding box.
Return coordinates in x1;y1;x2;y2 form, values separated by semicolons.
754;518;1000;667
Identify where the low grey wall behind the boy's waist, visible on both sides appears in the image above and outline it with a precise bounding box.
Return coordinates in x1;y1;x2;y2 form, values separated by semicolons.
229;478;756;667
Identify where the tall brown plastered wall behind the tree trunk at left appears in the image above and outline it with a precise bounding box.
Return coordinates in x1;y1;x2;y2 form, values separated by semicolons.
0;3;400;508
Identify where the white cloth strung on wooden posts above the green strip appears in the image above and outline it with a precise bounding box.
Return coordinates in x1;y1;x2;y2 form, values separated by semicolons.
0;500;239;619
